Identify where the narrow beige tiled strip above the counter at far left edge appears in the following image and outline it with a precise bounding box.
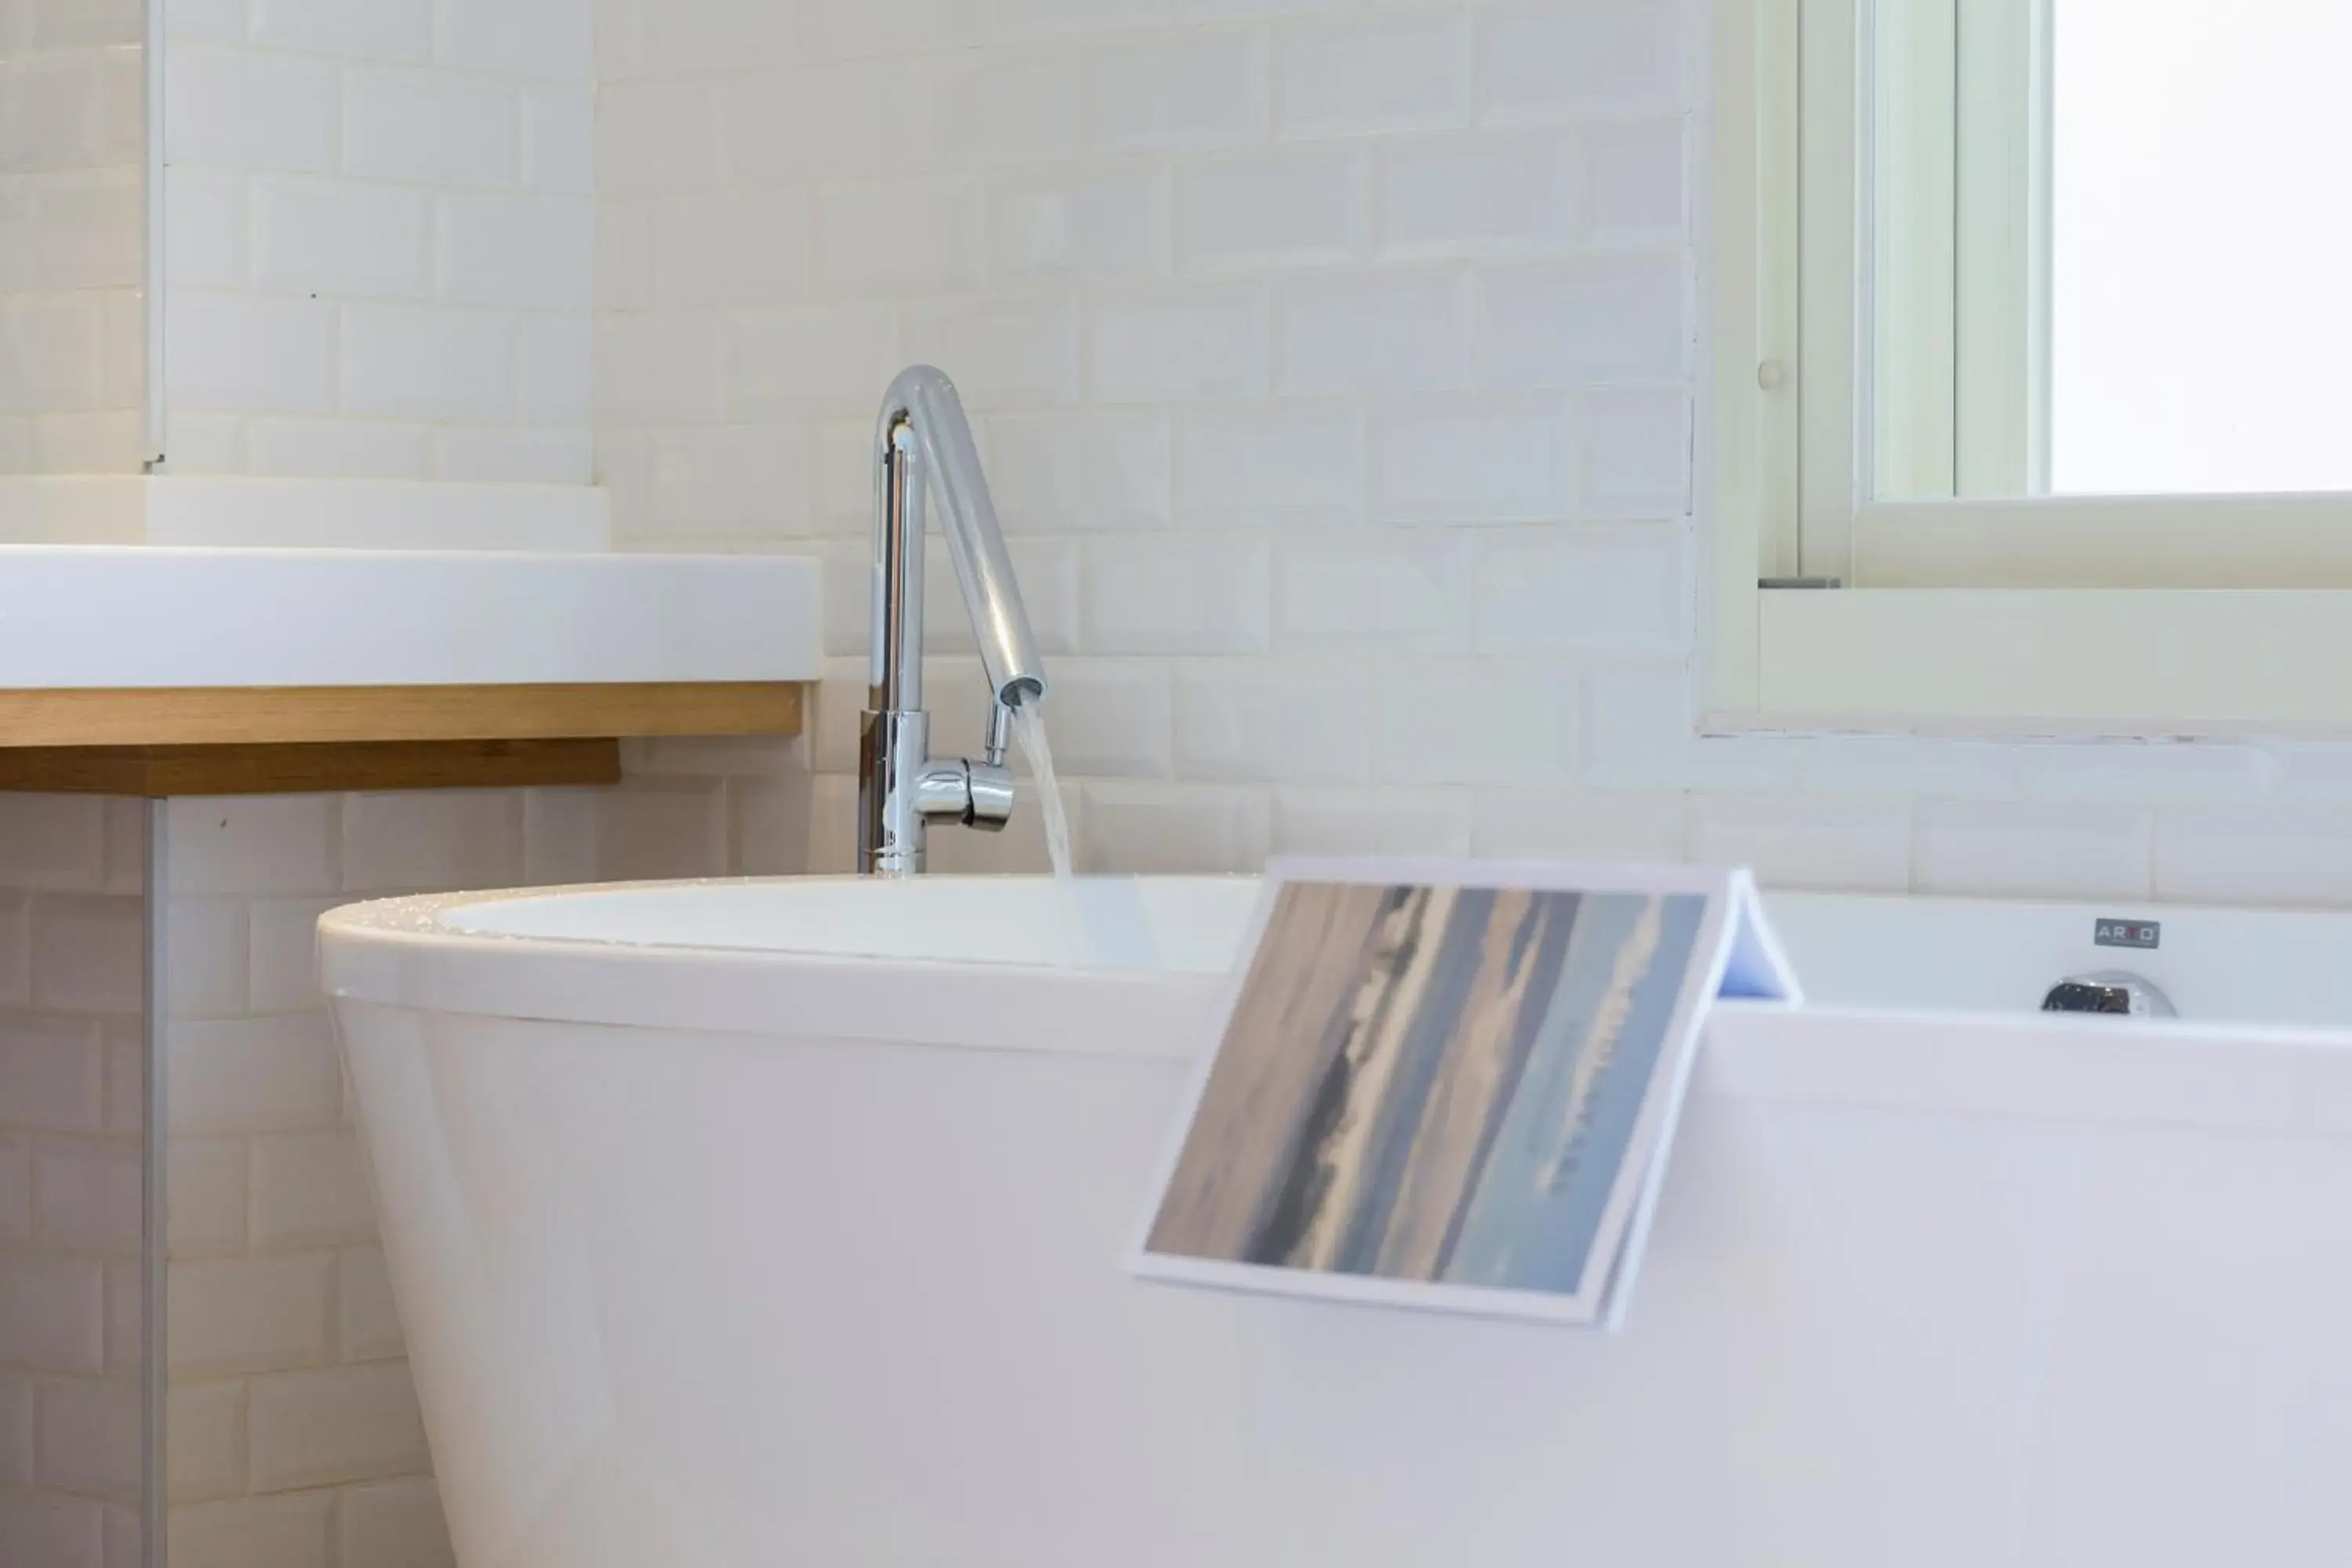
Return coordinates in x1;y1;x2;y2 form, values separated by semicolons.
0;0;146;475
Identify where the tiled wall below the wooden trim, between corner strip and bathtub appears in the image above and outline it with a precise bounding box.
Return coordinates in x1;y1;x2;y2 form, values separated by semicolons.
158;780;809;1568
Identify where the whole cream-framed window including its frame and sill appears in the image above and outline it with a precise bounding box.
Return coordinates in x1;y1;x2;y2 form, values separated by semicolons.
1712;0;2352;734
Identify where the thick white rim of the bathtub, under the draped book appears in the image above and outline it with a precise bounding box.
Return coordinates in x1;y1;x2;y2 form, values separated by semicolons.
320;877;2352;1138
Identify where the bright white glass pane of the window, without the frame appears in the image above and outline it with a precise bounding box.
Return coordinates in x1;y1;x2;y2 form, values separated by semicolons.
2051;0;2352;494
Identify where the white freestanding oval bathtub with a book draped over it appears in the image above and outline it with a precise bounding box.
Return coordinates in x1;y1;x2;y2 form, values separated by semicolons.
322;879;2352;1568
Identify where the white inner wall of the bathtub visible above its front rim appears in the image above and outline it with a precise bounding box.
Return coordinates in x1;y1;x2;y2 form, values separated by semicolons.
367;877;2352;1029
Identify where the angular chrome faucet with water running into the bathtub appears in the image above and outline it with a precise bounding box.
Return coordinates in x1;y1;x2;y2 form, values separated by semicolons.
858;365;1044;877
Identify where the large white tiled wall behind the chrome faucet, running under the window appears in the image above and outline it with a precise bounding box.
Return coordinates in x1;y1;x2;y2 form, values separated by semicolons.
597;0;2352;905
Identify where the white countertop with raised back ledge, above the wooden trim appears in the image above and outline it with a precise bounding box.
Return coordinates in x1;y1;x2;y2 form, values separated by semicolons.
0;477;821;691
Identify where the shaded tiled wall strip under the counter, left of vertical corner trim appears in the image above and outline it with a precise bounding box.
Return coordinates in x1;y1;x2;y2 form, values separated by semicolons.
0;799;146;1568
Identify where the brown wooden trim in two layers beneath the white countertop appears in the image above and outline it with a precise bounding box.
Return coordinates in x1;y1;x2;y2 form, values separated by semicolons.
0;682;807;797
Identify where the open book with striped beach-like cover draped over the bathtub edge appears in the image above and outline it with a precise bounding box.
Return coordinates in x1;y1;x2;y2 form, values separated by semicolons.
1134;860;1799;1328
